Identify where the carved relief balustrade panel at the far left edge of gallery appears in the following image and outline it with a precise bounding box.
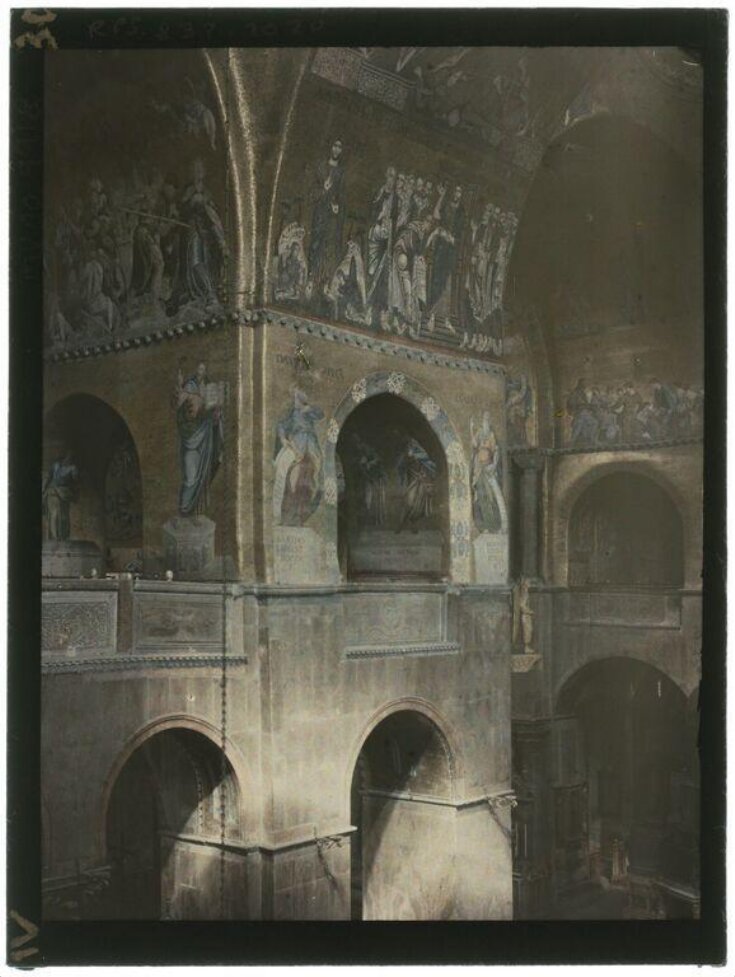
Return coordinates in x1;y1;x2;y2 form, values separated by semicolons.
41;593;117;656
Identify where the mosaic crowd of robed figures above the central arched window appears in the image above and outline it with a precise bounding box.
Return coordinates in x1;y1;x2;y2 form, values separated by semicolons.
273;138;518;355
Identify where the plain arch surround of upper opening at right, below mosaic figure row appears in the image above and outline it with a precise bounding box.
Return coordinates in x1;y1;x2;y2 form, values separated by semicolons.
553;459;694;586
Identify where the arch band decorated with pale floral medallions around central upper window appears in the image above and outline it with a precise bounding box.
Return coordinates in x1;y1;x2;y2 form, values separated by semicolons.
324;370;472;583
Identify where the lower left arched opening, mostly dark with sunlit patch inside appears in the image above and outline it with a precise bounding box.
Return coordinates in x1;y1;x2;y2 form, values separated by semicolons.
99;729;240;919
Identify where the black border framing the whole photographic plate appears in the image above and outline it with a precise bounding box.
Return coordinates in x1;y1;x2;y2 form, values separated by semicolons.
7;8;727;967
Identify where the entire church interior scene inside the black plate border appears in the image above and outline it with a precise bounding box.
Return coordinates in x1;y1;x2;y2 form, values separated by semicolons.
41;47;704;920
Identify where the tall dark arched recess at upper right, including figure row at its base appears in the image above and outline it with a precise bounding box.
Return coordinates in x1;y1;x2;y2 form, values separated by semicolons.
506;114;704;448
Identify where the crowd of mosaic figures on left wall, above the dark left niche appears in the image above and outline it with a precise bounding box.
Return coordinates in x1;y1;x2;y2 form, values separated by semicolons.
48;160;227;346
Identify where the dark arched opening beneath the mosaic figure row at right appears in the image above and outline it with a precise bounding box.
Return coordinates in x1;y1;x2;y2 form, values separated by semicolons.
568;472;684;588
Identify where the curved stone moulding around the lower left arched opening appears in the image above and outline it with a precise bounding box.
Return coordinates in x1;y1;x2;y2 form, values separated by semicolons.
96;713;251;858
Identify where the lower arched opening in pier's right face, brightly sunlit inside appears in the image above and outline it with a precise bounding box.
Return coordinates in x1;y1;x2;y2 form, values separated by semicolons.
350;710;454;919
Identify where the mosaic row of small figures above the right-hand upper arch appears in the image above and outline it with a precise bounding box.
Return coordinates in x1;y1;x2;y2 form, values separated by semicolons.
566;378;704;447
